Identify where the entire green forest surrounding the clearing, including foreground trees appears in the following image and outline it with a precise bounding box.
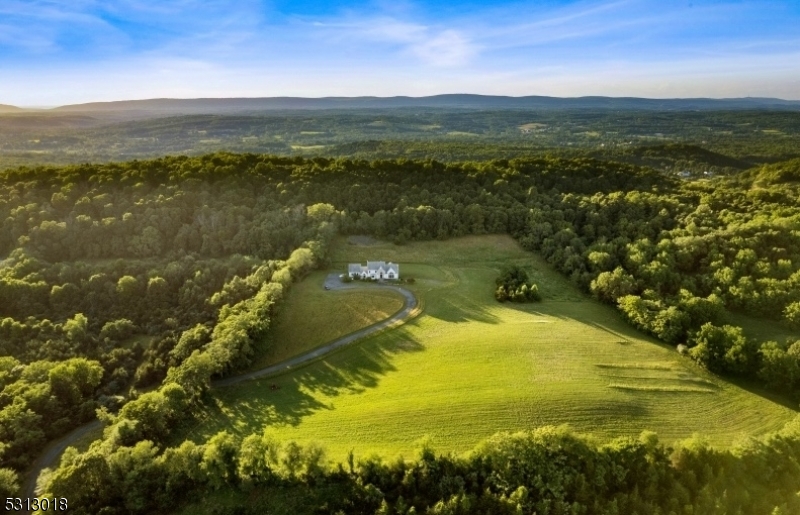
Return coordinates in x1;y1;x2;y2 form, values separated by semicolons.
0;151;800;515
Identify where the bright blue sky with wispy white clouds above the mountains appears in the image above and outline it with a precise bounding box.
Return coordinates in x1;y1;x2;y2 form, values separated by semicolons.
0;0;800;107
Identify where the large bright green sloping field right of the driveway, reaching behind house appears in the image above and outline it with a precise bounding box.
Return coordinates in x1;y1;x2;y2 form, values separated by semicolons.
178;236;795;466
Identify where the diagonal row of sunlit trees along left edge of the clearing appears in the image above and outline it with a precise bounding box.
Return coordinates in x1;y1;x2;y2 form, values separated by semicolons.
36;247;324;513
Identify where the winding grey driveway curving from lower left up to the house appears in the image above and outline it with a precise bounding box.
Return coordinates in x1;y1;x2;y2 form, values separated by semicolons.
22;274;417;506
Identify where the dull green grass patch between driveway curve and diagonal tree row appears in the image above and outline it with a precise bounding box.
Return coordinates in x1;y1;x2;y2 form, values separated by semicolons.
250;272;403;370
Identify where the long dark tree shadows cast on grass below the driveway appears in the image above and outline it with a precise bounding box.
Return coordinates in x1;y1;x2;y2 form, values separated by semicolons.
203;327;424;433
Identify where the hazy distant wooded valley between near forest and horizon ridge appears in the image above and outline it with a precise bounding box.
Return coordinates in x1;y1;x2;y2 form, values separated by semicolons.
0;107;800;176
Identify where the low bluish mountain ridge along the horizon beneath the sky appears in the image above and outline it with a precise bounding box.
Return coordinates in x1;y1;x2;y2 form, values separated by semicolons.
0;94;800;114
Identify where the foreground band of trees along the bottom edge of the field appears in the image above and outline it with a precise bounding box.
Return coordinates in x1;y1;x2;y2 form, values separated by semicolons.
39;421;800;515
